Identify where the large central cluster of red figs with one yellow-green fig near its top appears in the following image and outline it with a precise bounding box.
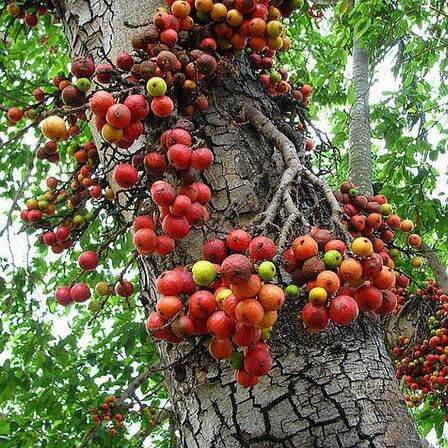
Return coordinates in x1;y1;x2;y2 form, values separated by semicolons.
146;229;286;387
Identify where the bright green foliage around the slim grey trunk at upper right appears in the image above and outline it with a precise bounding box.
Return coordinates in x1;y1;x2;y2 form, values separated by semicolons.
282;1;447;261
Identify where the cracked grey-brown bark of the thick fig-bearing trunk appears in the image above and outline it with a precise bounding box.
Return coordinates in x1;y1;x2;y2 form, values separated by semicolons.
59;0;425;448
